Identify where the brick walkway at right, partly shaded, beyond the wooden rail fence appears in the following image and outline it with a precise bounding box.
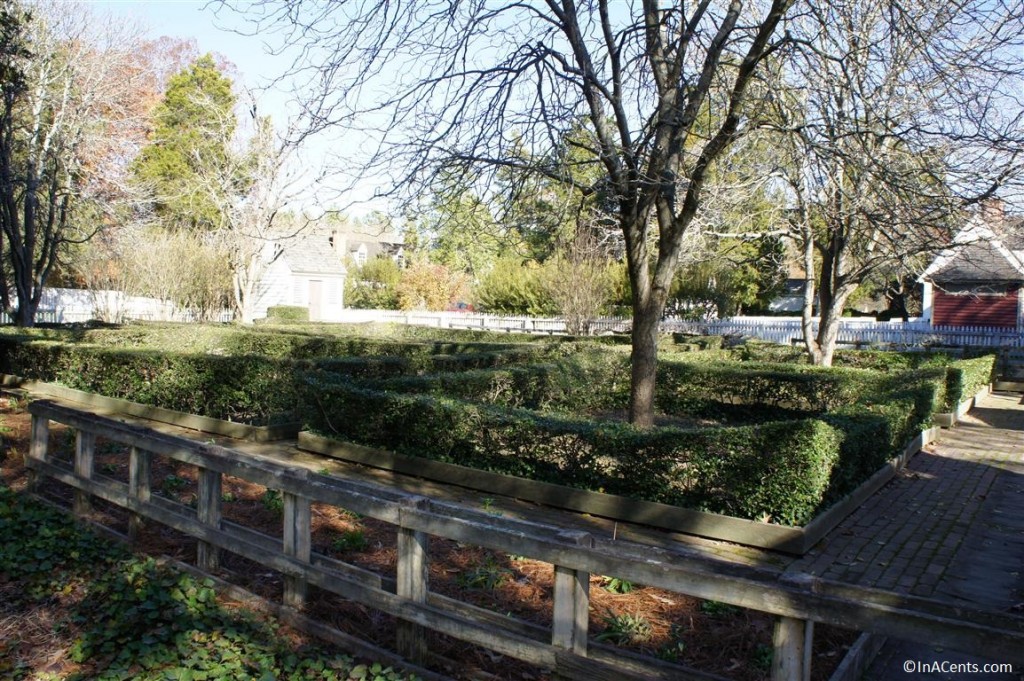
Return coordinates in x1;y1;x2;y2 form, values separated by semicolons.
788;394;1024;680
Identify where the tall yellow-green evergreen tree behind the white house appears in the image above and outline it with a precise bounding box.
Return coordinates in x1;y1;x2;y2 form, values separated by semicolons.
134;54;234;230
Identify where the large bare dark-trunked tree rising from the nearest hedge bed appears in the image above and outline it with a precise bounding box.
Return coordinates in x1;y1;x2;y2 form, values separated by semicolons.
222;0;795;426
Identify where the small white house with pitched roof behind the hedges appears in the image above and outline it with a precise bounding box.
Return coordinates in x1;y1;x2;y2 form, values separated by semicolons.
254;233;345;322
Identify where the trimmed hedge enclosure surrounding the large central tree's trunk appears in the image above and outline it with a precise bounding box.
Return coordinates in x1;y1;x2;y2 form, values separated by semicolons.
304;355;946;525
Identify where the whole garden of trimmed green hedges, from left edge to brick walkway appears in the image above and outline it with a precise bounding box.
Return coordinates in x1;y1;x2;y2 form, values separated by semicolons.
0;328;962;524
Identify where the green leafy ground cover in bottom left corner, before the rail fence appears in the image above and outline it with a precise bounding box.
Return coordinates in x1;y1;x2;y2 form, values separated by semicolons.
0;485;417;681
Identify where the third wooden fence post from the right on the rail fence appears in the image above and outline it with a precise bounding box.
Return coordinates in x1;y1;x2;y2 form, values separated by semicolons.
395;497;430;662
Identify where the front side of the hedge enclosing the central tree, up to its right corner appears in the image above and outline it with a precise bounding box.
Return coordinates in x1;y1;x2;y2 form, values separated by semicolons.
303;373;847;524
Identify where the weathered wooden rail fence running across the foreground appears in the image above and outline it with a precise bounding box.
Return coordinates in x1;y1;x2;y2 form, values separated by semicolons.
27;400;1024;681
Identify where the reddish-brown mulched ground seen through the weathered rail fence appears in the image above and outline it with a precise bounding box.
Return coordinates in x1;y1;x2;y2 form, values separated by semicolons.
0;400;856;681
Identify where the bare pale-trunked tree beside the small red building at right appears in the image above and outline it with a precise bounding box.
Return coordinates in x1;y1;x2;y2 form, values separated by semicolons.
772;0;1024;366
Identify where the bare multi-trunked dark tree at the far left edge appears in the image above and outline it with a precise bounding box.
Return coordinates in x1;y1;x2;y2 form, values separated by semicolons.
0;0;146;326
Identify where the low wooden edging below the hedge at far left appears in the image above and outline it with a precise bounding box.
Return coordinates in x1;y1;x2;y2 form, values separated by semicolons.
0;374;299;442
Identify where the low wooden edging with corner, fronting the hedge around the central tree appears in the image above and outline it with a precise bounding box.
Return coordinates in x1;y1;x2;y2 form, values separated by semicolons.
298;428;939;555
